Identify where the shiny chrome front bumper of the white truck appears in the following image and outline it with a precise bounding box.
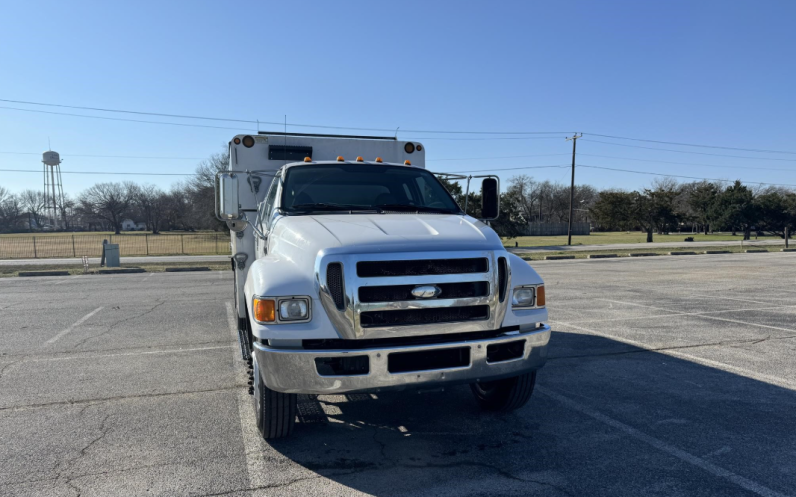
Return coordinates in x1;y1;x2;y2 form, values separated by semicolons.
253;325;550;395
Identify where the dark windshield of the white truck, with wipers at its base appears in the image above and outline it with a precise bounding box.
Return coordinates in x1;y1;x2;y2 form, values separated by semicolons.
281;164;461;214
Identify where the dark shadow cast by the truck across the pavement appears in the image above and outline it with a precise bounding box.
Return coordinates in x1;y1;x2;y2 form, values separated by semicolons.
270;332;796;496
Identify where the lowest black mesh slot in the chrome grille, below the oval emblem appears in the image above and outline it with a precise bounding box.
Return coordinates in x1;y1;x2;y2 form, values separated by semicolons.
360;305;489;328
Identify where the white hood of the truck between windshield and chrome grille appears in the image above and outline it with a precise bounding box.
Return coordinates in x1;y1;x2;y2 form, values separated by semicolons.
274;214;503;255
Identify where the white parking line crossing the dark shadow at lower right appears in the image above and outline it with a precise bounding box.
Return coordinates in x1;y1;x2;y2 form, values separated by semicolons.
536;386;786;497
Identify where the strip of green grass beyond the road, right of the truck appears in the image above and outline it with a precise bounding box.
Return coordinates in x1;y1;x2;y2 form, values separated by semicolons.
503;231;781;247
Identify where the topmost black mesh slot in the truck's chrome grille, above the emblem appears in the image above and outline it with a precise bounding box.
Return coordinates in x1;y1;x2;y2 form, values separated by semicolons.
357;257;489;278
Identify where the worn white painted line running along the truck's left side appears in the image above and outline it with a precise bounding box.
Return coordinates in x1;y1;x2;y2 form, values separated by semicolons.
226;302;273;488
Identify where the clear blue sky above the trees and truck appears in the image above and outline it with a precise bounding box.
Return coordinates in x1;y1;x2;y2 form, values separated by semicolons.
0;0;796;194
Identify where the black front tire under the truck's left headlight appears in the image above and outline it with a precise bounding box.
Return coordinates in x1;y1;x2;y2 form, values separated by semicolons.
254;361;298;440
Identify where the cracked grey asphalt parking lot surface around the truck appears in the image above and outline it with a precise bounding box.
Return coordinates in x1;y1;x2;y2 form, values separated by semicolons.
0;253;796;496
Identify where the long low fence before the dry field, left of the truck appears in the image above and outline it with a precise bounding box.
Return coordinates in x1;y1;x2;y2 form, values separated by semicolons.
0;233;230;259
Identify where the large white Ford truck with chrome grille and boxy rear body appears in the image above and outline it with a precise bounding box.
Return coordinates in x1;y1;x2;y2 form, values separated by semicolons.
216;132;550;439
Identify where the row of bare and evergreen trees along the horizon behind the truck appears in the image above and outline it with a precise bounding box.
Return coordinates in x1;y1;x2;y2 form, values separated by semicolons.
0;151;796;241
